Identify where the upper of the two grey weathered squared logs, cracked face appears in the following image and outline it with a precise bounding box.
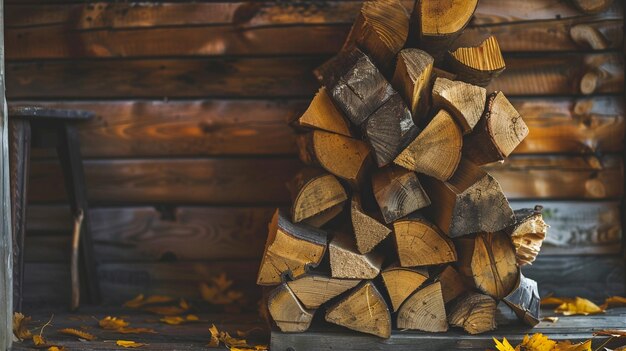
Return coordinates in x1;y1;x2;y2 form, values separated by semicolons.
314;48;395;126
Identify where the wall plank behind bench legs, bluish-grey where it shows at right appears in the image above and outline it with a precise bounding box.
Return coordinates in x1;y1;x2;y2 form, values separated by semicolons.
25;201;622;262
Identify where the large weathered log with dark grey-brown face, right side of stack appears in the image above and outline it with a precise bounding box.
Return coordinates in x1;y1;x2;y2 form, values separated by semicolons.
422;159;515;238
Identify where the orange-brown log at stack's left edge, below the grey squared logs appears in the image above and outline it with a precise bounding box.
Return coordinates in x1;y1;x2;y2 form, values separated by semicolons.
297;130;370;185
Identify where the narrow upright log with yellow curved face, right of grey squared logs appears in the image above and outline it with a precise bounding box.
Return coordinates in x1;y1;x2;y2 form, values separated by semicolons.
391;49;434;123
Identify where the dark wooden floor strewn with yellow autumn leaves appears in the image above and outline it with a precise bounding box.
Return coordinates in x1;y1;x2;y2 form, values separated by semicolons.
8;307;626;351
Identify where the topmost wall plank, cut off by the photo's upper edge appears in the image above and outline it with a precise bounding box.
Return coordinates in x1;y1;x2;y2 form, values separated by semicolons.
6;0;622;29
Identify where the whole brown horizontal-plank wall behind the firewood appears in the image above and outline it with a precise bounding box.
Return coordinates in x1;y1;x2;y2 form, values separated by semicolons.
5;0;624;304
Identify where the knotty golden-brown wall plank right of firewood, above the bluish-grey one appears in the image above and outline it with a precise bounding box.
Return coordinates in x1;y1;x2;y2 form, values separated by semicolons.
485;156;624;199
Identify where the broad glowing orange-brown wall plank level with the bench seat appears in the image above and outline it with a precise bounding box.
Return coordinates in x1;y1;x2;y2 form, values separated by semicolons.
13;97;625;158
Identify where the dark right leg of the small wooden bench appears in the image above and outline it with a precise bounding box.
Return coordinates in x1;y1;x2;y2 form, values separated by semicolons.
57;124;100;304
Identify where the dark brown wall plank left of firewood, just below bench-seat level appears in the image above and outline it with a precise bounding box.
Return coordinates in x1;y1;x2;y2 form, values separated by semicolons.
29;158;302;205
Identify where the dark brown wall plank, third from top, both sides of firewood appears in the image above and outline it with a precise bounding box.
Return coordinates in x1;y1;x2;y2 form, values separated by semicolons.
7;53;624;100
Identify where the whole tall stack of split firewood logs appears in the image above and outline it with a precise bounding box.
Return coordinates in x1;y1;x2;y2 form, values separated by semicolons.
257;0;547;338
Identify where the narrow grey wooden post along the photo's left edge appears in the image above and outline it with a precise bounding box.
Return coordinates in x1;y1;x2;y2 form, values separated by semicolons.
0;0;13;350
